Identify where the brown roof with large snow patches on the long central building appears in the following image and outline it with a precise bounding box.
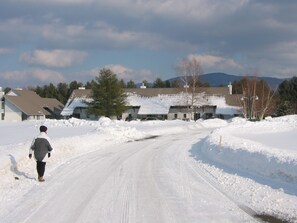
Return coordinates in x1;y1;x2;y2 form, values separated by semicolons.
61;87;240;116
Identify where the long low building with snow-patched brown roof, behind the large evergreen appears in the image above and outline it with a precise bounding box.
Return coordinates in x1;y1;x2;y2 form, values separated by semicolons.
61;86;240;120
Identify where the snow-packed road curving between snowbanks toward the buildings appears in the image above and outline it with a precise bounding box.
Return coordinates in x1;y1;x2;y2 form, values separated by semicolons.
1;130;256;223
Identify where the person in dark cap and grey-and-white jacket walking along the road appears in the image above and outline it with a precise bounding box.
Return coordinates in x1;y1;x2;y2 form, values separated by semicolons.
29;125;53;182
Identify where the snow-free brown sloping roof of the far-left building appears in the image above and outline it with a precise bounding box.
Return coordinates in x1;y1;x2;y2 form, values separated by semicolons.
4;90;64;115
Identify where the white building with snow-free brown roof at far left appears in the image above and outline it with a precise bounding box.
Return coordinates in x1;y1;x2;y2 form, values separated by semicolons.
4;89;64;121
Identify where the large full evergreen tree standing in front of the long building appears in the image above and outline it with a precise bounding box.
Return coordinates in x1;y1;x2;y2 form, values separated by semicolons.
87;69;127;118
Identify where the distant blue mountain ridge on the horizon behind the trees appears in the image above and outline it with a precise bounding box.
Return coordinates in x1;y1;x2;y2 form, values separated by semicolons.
168;73;286;90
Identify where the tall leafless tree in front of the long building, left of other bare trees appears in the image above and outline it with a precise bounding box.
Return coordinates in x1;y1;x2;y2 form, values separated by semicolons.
176;57;203;119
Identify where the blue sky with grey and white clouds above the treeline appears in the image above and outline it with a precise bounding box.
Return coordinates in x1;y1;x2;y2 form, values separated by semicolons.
0;0;297;87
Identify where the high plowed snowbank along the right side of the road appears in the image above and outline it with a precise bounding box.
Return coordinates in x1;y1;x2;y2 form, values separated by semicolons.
197;116;297;186
